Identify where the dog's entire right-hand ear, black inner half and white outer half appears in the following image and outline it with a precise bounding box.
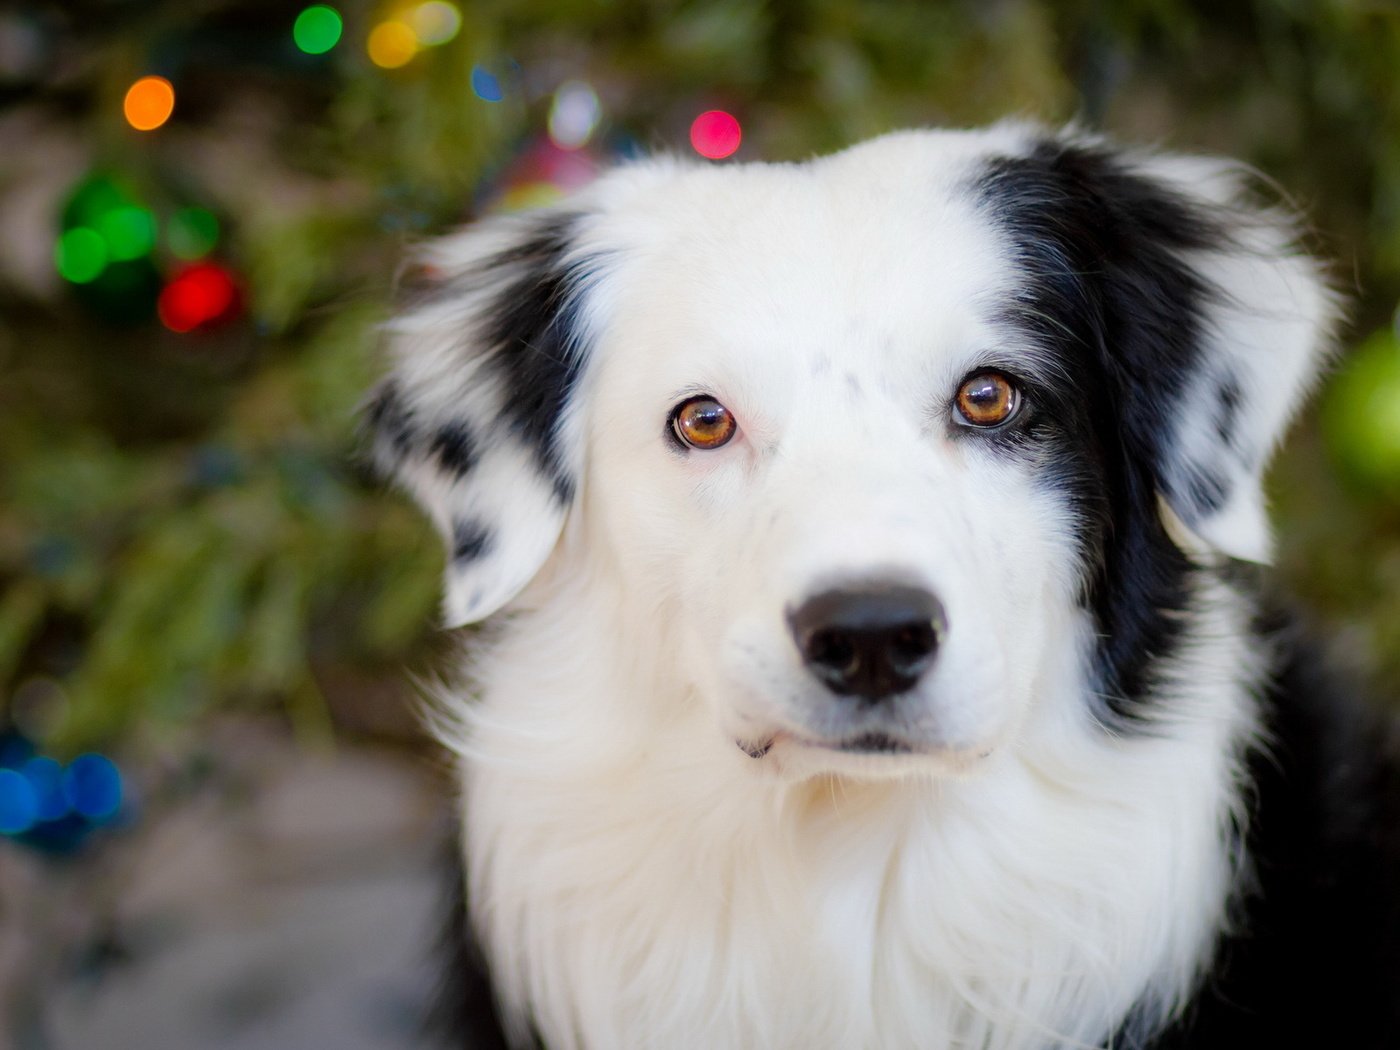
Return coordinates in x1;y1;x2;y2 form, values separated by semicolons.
983;133;1338;561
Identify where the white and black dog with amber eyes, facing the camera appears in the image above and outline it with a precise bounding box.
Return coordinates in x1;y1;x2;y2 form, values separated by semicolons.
370;125;1400;1050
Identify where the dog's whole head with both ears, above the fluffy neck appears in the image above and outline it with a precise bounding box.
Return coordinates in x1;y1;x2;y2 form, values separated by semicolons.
370;126;1333;774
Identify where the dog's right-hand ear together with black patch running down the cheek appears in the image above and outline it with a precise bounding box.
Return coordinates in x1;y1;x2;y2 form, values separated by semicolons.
969;137;1329;718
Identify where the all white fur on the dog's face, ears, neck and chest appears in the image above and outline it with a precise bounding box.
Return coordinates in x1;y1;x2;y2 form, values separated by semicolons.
383;126;1329;1050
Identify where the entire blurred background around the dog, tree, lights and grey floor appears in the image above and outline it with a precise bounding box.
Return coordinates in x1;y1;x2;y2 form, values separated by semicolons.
0;0;1400;1050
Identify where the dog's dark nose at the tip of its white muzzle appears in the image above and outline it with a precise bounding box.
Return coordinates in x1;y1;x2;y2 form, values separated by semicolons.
788;585;948;701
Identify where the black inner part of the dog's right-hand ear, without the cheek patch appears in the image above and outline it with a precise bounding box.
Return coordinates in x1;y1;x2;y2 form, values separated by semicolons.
977;140;1238;515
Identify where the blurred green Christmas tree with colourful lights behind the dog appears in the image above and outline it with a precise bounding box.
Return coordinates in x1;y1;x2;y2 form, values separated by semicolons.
0;0;1400;834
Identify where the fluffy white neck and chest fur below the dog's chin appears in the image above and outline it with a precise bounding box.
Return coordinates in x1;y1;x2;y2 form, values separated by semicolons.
442;578;1261;1050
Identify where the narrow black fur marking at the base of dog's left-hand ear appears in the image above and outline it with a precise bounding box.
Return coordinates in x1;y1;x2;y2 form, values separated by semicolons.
486;214;589;503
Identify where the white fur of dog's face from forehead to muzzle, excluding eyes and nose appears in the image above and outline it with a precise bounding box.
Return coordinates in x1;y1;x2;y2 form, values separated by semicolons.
560;137;1074;784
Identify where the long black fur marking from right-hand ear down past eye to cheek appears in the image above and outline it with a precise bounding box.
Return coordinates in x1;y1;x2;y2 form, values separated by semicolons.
973;140;1229;724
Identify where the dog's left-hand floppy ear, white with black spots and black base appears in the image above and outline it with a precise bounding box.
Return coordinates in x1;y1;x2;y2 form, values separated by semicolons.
367;210;595;626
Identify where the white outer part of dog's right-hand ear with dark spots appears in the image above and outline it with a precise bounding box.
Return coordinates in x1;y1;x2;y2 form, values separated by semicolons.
1125;157;1340;561
